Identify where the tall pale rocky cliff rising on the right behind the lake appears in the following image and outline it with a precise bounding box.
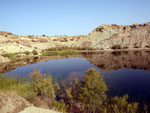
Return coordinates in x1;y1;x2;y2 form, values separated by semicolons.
75;23;150;50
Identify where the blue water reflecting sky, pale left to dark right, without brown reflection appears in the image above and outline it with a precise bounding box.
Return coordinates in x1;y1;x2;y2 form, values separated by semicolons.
6;58;150;102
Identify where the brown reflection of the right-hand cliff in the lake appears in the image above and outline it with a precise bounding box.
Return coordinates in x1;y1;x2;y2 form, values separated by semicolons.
84;51;150;70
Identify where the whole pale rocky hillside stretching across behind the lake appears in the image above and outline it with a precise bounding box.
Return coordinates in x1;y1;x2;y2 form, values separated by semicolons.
0;23;150;54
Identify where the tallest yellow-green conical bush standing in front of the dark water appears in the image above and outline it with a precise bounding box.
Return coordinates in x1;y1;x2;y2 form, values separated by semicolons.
79;68;107;113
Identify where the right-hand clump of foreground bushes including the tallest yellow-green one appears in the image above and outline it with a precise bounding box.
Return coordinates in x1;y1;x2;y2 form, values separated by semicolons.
61;69;139;113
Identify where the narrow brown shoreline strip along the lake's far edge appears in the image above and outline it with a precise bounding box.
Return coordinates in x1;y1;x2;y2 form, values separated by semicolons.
0;48;150;74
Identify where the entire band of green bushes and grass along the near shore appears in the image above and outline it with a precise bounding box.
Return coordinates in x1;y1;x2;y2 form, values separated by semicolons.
0;68;145;113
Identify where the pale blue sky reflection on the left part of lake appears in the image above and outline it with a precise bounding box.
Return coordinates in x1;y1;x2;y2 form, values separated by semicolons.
6;58;99;77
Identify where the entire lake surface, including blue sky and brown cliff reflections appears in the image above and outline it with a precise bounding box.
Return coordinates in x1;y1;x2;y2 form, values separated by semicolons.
5;51;150;103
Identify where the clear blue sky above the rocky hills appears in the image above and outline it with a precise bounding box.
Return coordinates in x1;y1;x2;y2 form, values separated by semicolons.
0;0;150;36
